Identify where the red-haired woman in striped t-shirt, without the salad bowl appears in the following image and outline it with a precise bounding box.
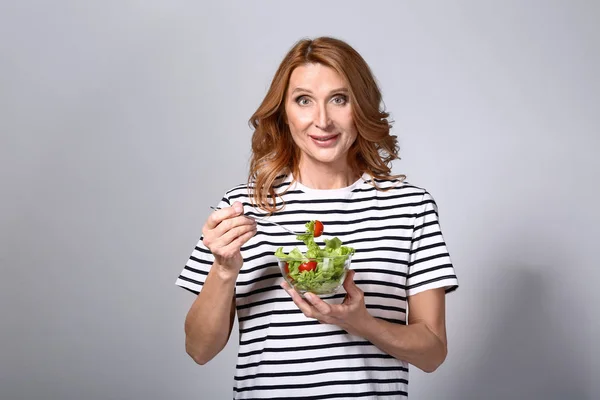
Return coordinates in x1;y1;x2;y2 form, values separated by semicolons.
177;37;458;399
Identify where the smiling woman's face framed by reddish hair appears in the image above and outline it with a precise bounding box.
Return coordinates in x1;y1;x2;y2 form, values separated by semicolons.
285;64;357;168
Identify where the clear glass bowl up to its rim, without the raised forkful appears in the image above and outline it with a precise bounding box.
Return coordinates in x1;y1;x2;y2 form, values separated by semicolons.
277;254;352;296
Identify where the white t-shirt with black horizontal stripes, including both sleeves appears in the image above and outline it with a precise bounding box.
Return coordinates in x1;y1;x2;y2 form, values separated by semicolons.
176;174;458;400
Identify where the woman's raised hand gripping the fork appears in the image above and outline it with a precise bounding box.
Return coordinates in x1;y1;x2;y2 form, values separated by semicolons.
202;201;256;276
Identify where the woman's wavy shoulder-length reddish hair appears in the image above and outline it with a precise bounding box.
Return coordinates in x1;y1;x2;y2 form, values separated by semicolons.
248;37;405;213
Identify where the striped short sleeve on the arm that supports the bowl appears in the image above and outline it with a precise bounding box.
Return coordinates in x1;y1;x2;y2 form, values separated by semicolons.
406;192;458;296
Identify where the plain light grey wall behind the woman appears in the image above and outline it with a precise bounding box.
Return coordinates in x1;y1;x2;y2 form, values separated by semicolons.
0;0;600;400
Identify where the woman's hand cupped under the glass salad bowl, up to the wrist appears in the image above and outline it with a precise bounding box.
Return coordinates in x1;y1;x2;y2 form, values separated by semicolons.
281;270;373;338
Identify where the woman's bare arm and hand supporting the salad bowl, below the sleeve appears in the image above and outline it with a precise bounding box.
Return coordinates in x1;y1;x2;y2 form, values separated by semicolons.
282;271;447;372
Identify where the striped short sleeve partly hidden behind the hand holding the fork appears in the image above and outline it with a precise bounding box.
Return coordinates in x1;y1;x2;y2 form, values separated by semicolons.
175;197;230;294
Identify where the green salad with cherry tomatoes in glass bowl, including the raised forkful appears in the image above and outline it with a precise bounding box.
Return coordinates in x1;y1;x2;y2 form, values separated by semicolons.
275;220;355;296
